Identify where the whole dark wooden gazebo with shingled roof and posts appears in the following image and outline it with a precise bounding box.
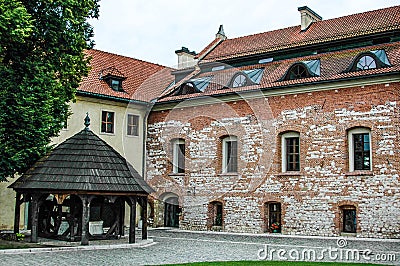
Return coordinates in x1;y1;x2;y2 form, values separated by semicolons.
10;116;153;245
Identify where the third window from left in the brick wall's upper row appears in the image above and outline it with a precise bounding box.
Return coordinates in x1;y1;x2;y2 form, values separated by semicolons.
282;132;300;172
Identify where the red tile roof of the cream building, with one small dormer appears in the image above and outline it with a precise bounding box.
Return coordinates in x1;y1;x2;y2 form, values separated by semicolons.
78;49;174;102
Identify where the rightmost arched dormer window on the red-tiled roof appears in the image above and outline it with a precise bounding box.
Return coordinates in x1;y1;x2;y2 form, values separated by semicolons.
348;50;390;71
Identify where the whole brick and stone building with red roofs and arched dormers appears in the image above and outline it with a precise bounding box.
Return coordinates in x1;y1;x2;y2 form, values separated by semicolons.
146;6;400;238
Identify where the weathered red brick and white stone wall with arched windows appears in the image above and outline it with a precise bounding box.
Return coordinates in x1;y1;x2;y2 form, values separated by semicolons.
147;83;400;238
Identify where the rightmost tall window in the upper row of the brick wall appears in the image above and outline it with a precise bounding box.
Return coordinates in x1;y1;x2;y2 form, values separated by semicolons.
348;128;372;172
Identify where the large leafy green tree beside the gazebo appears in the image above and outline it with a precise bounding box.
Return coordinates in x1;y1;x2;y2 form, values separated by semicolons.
0;0;99;181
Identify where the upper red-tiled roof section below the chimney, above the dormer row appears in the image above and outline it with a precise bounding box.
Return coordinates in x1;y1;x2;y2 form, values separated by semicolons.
200;6;400;61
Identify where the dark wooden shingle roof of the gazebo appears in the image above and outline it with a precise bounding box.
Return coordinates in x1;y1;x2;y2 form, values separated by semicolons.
10;129;153;194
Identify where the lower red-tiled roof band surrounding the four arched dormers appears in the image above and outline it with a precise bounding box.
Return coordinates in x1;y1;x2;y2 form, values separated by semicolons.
159;42;400;102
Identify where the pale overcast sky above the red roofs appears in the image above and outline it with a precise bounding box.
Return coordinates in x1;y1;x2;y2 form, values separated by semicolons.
90;0;400;67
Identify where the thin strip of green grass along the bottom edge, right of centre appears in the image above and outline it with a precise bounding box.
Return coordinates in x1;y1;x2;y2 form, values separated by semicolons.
168;261;382;266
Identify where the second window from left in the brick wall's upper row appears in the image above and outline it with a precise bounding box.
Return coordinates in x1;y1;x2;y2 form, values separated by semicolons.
222;136;238;173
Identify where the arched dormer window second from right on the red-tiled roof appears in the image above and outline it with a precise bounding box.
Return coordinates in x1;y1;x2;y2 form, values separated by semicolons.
283;60;321;80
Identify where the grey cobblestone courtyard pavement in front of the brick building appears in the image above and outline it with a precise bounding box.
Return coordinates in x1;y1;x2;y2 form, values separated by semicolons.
0;229;400;266
